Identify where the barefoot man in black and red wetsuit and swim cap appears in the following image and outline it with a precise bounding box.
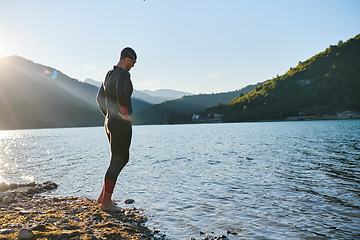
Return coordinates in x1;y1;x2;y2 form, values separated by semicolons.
96;47;137;210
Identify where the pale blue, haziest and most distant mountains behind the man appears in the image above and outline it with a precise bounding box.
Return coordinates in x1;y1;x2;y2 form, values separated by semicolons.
84;78;193;104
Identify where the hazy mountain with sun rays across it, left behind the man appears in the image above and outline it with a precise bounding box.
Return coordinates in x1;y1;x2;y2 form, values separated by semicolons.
0;56;150;129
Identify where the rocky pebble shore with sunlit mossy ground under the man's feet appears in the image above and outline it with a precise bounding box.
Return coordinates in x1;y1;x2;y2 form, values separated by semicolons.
0;182;165;240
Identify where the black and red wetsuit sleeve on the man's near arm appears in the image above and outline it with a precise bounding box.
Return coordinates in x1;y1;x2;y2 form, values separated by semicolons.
116;73;131;116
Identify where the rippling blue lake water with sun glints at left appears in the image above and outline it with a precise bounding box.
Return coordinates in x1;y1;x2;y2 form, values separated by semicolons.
0;120;360;239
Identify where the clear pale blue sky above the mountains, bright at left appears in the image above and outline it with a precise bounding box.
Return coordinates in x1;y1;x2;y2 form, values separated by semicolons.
0;0;360;93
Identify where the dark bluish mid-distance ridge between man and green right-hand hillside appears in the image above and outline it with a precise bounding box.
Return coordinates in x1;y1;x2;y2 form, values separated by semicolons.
133;83;261;124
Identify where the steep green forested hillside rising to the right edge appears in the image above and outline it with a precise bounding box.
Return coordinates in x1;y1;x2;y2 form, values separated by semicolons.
207;34;360;122
